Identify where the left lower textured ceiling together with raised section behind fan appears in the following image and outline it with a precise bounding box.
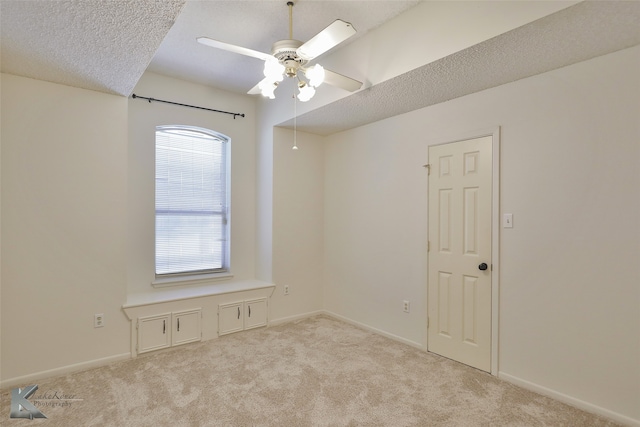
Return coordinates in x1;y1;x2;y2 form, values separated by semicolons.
0;0;418;96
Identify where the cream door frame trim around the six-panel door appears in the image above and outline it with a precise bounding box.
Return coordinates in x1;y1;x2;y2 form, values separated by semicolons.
425;126;500;377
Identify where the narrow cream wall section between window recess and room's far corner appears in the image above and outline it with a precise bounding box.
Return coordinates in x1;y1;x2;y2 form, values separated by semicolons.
271;128;324;320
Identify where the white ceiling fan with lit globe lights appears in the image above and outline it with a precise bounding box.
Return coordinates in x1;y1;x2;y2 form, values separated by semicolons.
196;1;362;102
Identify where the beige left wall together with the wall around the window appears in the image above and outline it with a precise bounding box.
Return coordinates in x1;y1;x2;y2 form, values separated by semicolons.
0;74;256;385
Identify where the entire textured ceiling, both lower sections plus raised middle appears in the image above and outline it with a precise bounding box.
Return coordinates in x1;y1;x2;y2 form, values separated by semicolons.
0;0;640;135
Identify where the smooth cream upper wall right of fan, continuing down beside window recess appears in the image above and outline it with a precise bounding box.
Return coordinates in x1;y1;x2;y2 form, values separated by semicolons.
256;0;577;288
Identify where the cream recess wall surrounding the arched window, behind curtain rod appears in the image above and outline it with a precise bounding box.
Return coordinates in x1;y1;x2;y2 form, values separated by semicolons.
127;73;256;294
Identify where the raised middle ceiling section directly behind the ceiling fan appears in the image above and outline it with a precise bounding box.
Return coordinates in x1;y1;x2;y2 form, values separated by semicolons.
149;0;419;93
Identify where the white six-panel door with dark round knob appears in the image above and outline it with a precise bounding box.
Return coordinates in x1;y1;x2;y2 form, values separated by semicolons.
428;136;492;372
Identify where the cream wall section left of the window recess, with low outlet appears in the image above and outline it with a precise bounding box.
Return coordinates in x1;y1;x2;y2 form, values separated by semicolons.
1;74;129;380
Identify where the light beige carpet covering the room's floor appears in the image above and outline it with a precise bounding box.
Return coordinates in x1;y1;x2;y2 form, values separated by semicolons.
0;316;616;427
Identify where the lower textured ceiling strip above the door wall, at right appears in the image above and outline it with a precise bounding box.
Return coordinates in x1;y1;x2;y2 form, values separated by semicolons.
282;1;640;135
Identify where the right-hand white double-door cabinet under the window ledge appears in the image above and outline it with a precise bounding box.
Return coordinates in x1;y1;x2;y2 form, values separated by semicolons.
218;298;268;335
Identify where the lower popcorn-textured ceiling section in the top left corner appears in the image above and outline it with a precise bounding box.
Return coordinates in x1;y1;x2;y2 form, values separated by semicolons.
0;0;186;96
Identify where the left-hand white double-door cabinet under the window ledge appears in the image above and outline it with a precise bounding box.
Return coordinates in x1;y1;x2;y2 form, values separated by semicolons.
138;309;202;354
